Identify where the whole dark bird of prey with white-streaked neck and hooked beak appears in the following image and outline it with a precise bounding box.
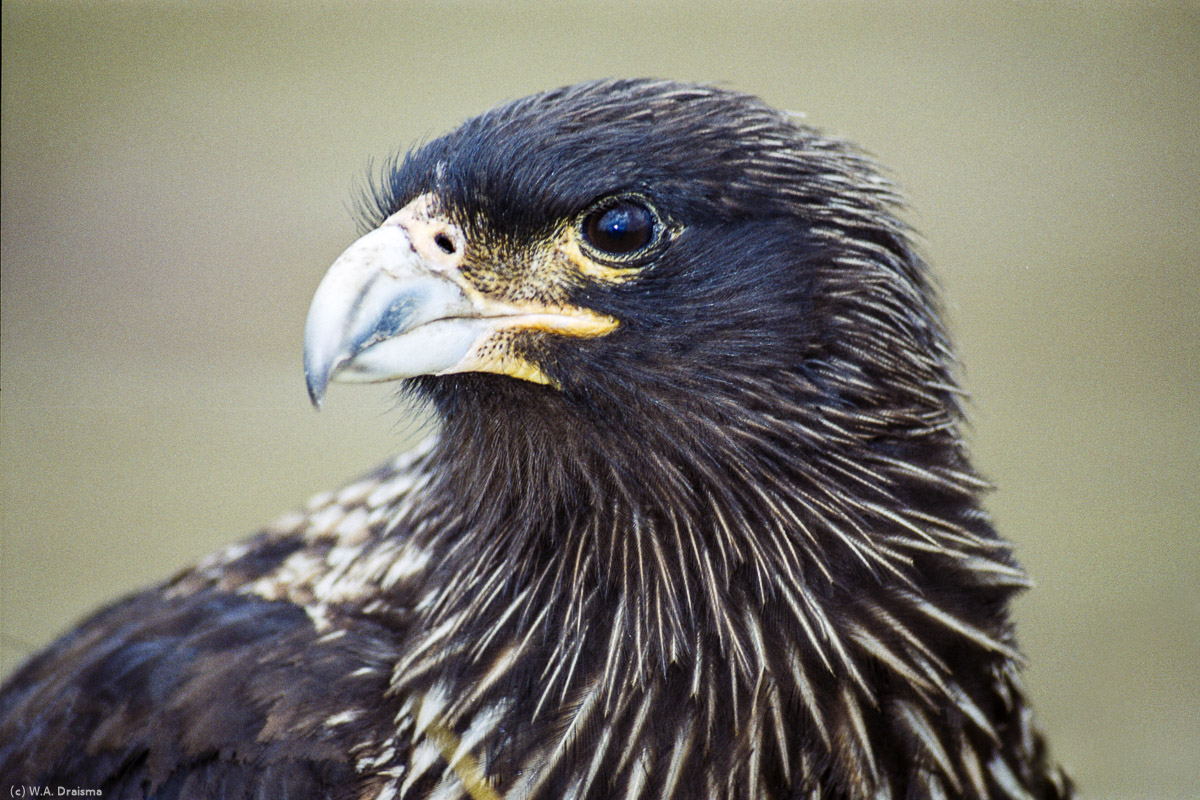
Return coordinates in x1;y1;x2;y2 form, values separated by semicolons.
0;79;1073;800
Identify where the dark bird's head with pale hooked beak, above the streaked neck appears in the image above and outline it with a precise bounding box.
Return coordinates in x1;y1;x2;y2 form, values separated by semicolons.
305;80;953;455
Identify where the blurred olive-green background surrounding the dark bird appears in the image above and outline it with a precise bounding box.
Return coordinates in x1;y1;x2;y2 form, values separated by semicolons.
0;1;1200;800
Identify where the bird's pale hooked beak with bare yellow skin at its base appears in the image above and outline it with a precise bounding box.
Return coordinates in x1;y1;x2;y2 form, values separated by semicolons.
305;194;624;407
